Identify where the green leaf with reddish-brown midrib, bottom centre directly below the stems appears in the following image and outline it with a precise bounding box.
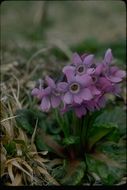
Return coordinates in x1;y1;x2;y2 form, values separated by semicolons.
60;161;86;185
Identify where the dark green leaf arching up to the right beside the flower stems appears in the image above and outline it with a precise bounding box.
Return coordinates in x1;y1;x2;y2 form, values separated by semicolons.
87;123;118;150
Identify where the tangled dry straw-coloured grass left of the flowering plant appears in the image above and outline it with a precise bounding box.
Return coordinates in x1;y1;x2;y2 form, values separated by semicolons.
0;42;69;186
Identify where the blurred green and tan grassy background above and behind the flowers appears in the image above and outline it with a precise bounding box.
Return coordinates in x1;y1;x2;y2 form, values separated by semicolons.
1;0;126;93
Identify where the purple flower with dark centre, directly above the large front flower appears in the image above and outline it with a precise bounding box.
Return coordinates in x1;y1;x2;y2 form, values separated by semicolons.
63;53;94;75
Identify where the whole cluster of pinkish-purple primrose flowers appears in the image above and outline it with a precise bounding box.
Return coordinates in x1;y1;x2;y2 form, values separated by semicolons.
32;49;126;117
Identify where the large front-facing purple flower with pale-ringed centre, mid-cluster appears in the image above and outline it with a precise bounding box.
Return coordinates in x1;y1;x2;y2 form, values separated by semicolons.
61;70;93;104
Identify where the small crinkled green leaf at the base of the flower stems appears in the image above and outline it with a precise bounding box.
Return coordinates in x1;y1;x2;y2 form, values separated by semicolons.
63;136;80;145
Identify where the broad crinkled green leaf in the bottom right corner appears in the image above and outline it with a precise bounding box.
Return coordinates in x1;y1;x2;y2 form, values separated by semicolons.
87;151;124;185
